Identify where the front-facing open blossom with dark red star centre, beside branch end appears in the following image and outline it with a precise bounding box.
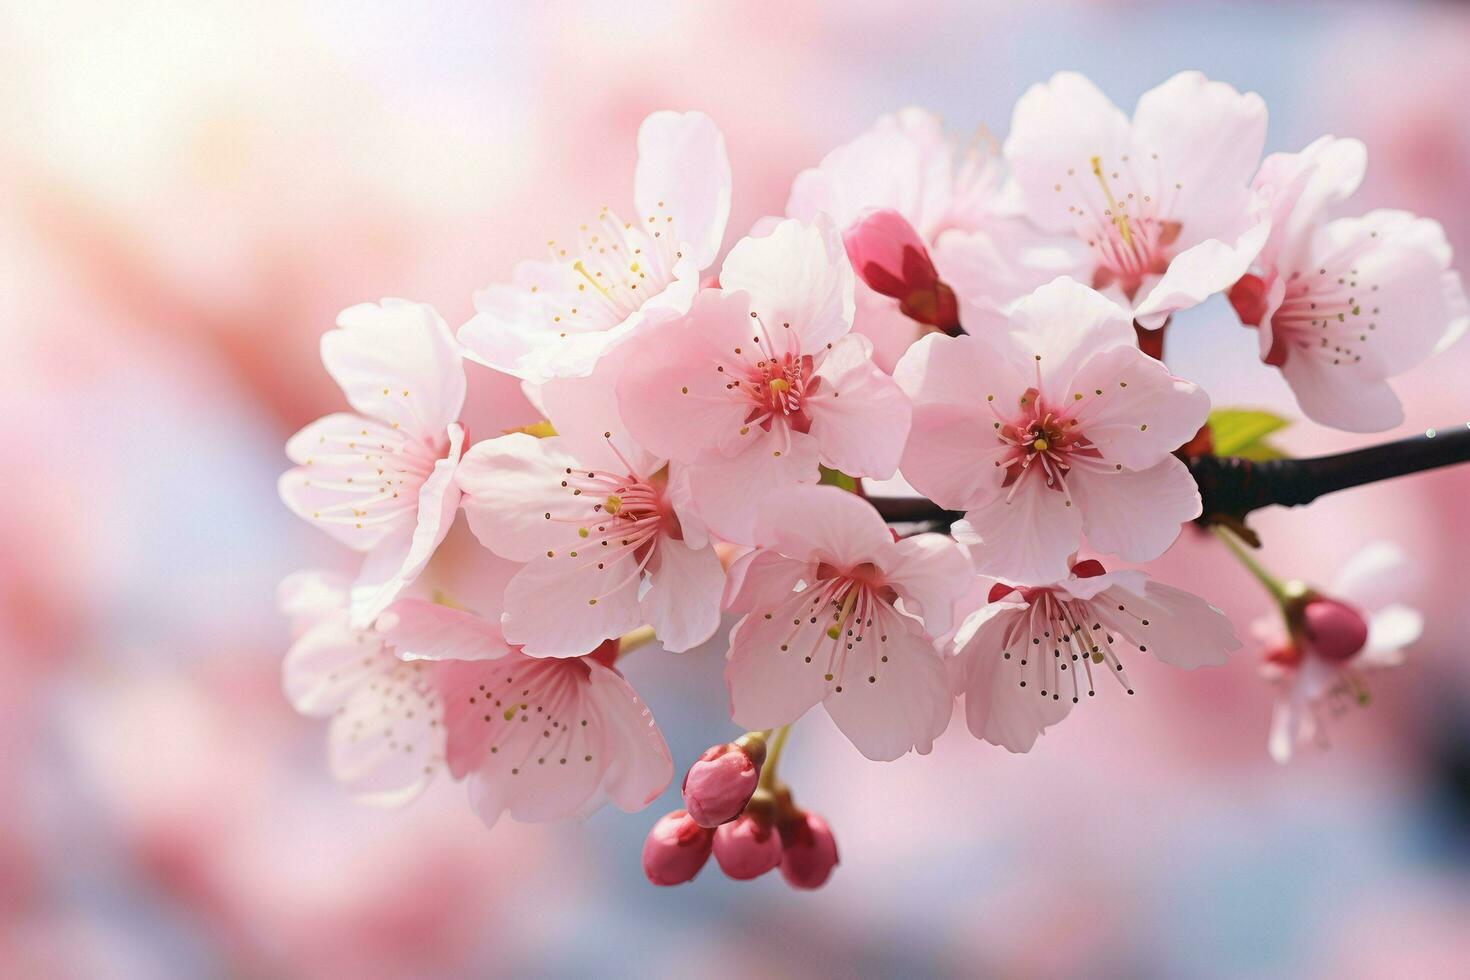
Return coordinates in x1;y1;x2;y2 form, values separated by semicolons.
894;278;1210;582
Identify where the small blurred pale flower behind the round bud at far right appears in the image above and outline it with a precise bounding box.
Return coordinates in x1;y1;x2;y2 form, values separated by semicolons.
1251;541;1424;763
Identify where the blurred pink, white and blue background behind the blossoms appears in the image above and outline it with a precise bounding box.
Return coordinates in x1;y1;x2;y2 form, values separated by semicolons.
0;0;1470;977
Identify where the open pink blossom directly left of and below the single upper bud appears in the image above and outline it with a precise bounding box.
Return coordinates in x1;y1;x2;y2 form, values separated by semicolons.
617;217;910;542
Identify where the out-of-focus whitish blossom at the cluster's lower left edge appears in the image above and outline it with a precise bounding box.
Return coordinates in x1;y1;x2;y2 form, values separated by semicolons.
278;572;445;807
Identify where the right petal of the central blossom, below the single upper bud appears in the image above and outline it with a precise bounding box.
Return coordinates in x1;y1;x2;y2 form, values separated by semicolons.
807;335;911;479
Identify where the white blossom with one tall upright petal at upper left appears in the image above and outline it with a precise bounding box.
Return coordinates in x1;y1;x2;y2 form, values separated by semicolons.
460;112;731;381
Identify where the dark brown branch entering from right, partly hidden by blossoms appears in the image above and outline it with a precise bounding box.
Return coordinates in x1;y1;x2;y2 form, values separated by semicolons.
869;425;1470;544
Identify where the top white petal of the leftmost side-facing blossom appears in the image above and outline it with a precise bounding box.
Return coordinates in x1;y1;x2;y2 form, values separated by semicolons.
322;300;465;438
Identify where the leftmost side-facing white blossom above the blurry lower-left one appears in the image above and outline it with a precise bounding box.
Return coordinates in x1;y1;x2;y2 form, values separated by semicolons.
279;300;465;626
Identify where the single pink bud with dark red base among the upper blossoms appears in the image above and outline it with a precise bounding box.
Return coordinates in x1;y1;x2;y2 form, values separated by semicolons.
842;207;960;331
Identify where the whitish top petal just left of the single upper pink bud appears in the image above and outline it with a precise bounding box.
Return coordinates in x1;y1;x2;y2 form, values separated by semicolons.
720;215;854;354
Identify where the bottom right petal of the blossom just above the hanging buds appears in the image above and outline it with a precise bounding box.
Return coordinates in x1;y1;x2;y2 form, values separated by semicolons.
823;610;954;763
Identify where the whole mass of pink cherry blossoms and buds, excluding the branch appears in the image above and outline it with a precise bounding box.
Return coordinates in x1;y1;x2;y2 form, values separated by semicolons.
279;72;1470;887
